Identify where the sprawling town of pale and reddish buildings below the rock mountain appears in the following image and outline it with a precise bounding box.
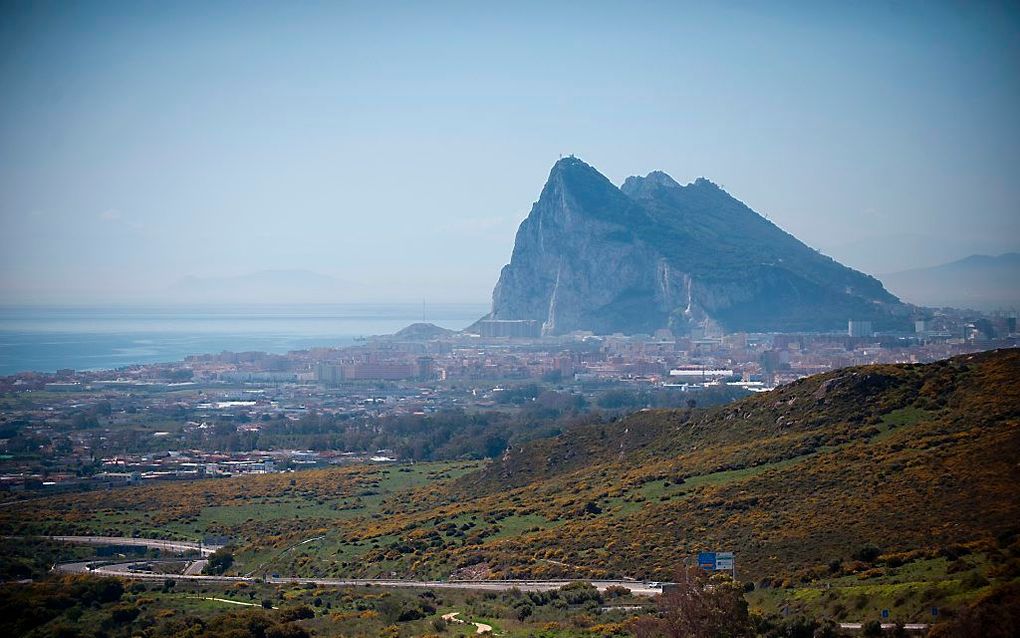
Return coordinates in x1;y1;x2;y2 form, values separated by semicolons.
0;310;1017;493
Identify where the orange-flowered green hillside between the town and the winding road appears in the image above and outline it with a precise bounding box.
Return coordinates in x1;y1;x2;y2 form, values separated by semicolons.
0;350;1020;583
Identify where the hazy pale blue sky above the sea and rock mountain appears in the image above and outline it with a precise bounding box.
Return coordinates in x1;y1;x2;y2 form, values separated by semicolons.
0;1;1020;301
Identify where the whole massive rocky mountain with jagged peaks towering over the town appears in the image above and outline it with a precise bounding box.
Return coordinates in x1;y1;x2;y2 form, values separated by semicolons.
490;157;899;334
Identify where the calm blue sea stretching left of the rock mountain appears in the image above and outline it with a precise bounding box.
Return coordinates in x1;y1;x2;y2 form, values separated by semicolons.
0;303;489;375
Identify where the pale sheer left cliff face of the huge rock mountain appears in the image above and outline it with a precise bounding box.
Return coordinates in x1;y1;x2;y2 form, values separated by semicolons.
492;159;671;334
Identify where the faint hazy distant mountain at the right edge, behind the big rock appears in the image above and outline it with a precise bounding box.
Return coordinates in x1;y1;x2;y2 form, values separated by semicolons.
880;252;1020;310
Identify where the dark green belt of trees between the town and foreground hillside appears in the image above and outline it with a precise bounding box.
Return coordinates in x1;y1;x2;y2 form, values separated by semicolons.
13;383;742;460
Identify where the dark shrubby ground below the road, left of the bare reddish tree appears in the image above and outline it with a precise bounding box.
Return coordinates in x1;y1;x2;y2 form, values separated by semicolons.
0;541;648;638
